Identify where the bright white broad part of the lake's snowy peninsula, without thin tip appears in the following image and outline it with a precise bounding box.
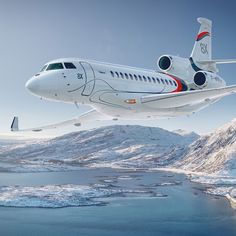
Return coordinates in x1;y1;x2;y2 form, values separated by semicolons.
0;184;107;208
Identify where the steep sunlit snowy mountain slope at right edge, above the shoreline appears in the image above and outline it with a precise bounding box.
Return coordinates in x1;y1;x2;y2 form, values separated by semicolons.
174;119;236;174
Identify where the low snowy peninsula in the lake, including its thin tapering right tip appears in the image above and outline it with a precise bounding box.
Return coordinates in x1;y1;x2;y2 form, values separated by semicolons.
0;184;168;208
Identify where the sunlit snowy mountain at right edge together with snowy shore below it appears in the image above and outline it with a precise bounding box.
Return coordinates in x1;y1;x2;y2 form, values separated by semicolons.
173;119;236;208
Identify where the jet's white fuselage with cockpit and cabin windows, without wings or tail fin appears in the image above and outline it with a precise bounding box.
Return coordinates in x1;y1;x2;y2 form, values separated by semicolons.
26;58;224;119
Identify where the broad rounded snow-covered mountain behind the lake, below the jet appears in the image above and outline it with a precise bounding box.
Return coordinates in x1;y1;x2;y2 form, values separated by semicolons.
0;125;198;171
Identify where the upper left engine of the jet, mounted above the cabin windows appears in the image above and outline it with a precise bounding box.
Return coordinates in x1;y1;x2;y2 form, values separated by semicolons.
157;55;190;77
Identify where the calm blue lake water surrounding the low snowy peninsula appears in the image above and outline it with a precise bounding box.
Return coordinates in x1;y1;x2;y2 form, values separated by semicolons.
0;169;236;236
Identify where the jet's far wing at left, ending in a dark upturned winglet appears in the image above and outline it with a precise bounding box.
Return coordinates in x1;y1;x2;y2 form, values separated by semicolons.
11;109;112;132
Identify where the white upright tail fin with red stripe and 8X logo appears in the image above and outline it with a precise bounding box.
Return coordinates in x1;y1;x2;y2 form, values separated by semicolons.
190;18;212;61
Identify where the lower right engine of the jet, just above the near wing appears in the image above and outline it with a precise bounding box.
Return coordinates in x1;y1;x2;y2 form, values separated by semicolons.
193;71;226;88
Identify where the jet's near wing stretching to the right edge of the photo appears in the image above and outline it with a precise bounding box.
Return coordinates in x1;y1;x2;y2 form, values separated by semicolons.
141;85;236;108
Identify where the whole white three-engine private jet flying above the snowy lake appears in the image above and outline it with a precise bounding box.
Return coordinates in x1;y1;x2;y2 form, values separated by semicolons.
11;18;236;131
